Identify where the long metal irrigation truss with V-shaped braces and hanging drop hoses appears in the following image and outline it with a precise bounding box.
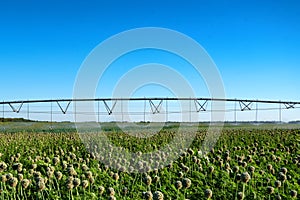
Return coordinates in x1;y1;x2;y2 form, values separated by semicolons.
0;97;300;121
